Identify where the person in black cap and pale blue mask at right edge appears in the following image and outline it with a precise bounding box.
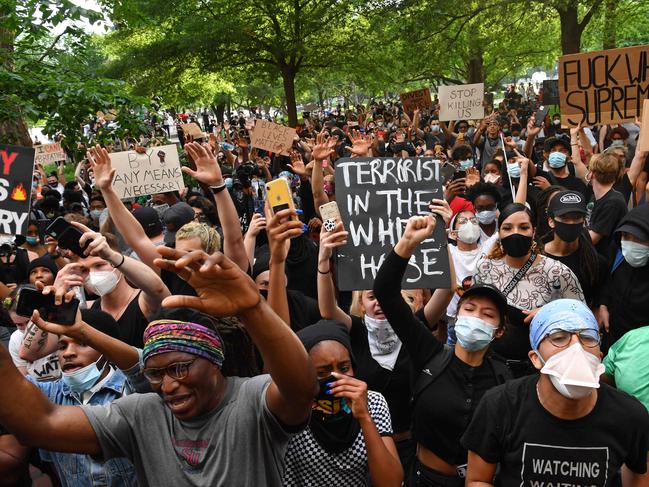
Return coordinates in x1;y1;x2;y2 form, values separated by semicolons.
598;203;649;344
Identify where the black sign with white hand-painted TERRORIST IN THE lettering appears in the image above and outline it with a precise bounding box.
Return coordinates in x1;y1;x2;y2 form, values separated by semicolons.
336;157;450;291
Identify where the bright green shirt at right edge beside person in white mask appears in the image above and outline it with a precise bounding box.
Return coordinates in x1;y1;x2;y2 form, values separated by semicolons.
604;326;649;410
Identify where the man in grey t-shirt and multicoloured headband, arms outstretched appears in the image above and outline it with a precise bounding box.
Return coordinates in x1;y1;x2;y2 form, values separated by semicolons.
0;247;317;487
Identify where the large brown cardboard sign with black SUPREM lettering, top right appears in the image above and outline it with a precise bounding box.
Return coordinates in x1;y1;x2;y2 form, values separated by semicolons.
559;46;649;127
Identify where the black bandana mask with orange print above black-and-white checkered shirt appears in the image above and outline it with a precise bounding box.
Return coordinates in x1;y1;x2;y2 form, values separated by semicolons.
309;375;361;454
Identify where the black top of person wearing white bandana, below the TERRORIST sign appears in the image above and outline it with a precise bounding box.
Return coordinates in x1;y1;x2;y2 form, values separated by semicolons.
349;316;412;433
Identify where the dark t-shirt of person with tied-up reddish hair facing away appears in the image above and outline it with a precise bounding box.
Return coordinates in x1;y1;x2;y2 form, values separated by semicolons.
586;189;627;261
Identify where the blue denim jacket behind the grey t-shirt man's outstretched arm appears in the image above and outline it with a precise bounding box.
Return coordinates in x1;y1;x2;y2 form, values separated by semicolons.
27;351;151;487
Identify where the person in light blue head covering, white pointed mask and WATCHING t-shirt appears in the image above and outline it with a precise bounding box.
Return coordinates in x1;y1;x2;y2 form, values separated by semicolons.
462;299;649;487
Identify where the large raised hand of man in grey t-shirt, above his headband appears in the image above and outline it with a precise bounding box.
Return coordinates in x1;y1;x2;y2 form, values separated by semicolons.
154;247;261;317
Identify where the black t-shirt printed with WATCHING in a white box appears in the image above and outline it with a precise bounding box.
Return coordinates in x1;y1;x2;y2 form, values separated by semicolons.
462;375;649;487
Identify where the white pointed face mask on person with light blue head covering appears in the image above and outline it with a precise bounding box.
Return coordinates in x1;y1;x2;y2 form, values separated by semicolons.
536;343;604;399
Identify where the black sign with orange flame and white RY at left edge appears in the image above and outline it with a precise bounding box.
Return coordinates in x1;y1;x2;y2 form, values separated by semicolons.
0;144;36;235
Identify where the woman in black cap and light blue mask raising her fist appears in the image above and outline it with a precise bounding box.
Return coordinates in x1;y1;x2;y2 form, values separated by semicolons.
374;216;510;487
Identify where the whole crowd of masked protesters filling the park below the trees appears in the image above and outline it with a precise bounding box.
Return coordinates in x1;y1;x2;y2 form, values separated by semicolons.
0;82;649;487
